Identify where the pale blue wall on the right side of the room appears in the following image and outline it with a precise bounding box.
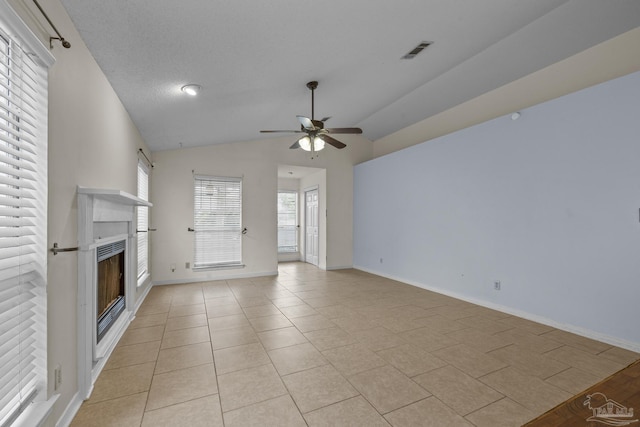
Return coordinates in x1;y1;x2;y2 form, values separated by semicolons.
354;73;640;351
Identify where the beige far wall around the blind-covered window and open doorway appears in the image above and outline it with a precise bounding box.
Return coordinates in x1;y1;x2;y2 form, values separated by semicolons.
151;135;373;284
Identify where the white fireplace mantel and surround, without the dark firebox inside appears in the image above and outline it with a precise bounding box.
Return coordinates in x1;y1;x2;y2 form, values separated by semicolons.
77;186;152;399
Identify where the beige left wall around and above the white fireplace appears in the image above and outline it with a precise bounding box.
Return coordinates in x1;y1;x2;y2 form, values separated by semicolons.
7;0;149;425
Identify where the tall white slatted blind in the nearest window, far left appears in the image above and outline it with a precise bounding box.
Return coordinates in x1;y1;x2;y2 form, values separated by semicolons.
0;20;47;425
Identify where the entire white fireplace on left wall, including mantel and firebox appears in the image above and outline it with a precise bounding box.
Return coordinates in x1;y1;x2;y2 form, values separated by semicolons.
77;187;152;399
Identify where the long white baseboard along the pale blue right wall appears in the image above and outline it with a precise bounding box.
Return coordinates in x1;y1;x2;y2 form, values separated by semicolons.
353;265;640;353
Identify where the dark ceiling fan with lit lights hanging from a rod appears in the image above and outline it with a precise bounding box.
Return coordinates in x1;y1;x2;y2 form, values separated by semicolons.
260;81;362;152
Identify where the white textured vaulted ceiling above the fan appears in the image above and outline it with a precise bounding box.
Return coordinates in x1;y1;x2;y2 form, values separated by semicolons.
62;0;640;151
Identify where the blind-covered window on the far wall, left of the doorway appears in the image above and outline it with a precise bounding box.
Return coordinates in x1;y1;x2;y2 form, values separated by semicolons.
193;175;242;269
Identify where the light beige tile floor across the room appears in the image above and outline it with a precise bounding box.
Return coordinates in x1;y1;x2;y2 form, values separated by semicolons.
72;263;640;427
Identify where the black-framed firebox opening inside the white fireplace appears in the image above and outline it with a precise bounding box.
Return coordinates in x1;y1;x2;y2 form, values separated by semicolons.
96;240;126;342
